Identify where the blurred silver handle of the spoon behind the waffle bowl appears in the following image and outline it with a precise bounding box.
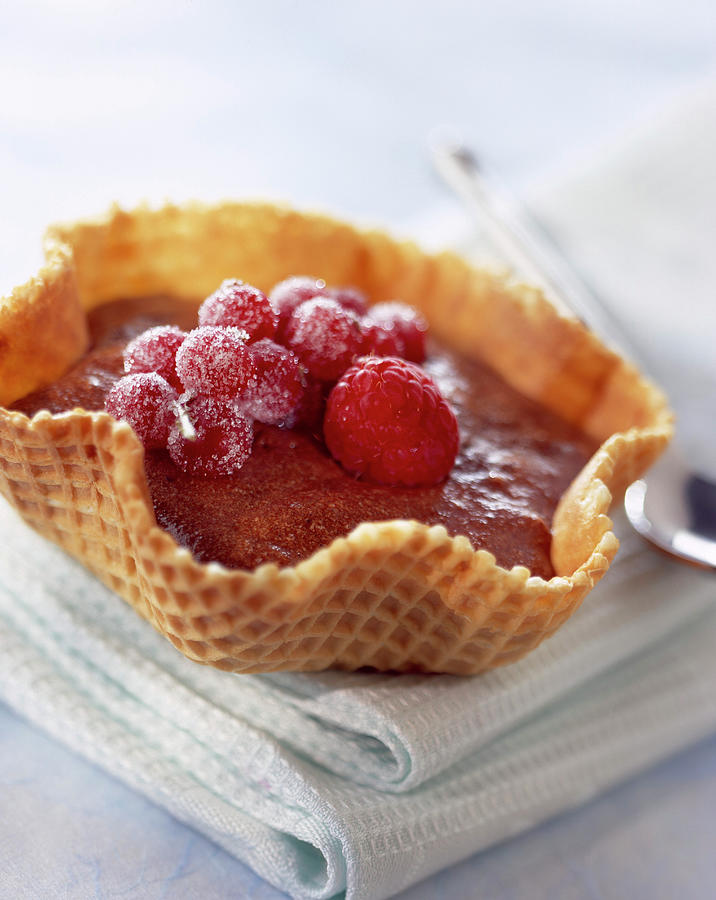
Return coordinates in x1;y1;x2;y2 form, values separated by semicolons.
432;142;644;368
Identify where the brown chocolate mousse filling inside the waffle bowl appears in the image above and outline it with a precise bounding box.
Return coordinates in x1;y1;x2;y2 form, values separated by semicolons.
13;297;596;578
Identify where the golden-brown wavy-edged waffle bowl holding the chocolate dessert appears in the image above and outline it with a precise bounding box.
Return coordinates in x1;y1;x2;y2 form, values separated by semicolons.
0;204;672;674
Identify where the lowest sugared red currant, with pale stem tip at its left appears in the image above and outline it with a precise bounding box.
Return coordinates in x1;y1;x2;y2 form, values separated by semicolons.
167;394;253;475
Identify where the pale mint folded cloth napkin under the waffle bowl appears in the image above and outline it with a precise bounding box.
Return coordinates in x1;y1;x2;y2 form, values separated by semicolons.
0;79;716;898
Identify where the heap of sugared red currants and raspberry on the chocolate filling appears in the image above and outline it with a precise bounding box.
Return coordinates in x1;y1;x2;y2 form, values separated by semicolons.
105;277;457;484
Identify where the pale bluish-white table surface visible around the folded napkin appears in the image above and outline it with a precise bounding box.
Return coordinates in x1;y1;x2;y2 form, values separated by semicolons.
0;0;716;900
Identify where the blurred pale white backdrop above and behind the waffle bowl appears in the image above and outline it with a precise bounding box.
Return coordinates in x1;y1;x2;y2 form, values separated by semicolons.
0;0;716;291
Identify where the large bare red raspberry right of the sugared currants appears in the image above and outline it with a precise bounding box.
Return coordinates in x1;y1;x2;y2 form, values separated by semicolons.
323;356;459;486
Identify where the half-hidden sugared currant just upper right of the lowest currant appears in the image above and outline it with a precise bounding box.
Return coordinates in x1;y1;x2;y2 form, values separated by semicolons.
244;338;305;425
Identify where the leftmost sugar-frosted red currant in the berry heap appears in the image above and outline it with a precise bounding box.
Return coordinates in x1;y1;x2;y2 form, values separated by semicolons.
104;372;177;448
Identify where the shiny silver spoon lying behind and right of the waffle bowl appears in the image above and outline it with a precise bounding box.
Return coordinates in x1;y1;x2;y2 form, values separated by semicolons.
432;144;716;569
